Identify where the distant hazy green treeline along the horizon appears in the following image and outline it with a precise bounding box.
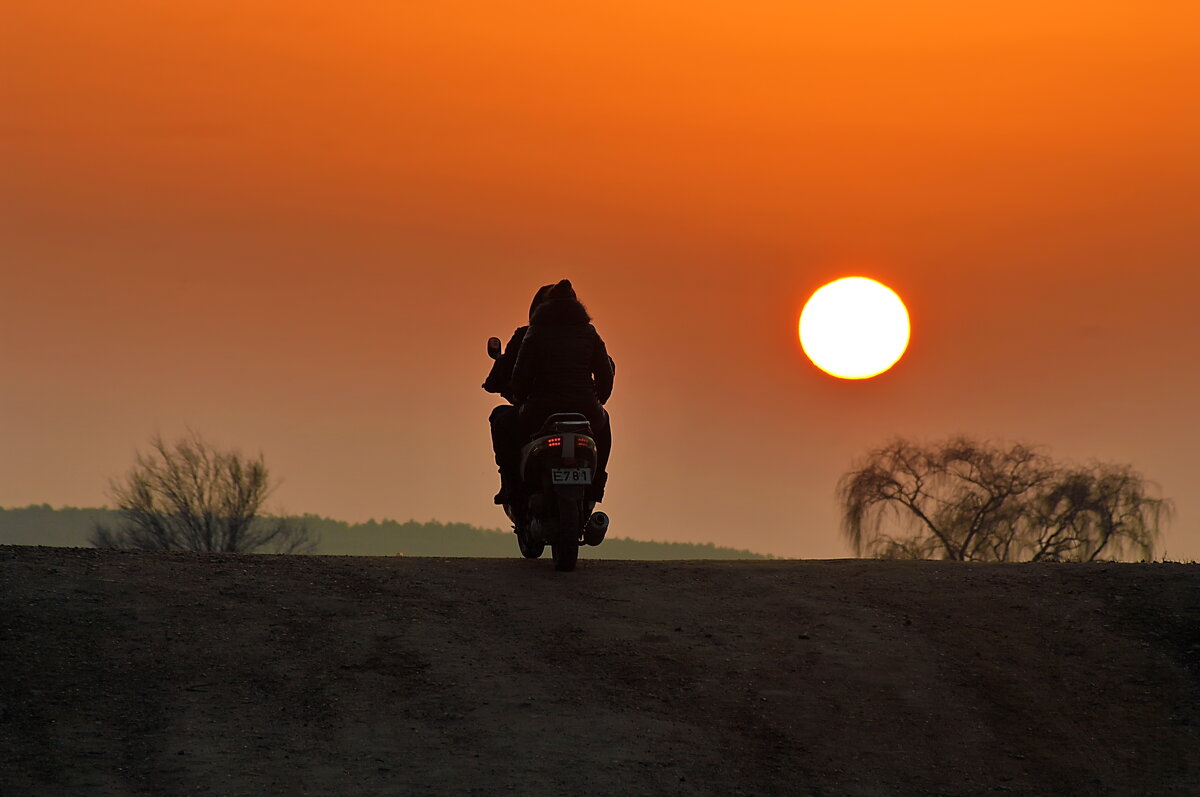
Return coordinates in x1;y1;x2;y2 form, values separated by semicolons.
0;504;768;559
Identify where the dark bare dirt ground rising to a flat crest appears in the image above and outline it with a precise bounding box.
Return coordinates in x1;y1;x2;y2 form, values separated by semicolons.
0;546;1200;796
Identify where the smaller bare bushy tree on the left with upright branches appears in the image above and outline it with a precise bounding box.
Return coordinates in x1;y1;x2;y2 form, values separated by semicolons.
91;432;317;553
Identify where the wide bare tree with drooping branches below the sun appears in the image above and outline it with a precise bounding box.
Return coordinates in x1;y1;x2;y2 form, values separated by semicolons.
838;437;1171;562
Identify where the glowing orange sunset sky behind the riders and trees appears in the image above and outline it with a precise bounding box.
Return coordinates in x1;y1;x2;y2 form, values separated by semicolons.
0;0;1200;557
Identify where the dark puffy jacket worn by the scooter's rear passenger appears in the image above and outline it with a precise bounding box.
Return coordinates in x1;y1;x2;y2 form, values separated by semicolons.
511;295;613;413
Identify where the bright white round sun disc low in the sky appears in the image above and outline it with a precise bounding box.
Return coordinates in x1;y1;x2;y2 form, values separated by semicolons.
800;277;910;379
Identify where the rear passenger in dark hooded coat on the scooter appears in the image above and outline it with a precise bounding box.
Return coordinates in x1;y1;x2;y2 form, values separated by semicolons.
511;280;613;502
